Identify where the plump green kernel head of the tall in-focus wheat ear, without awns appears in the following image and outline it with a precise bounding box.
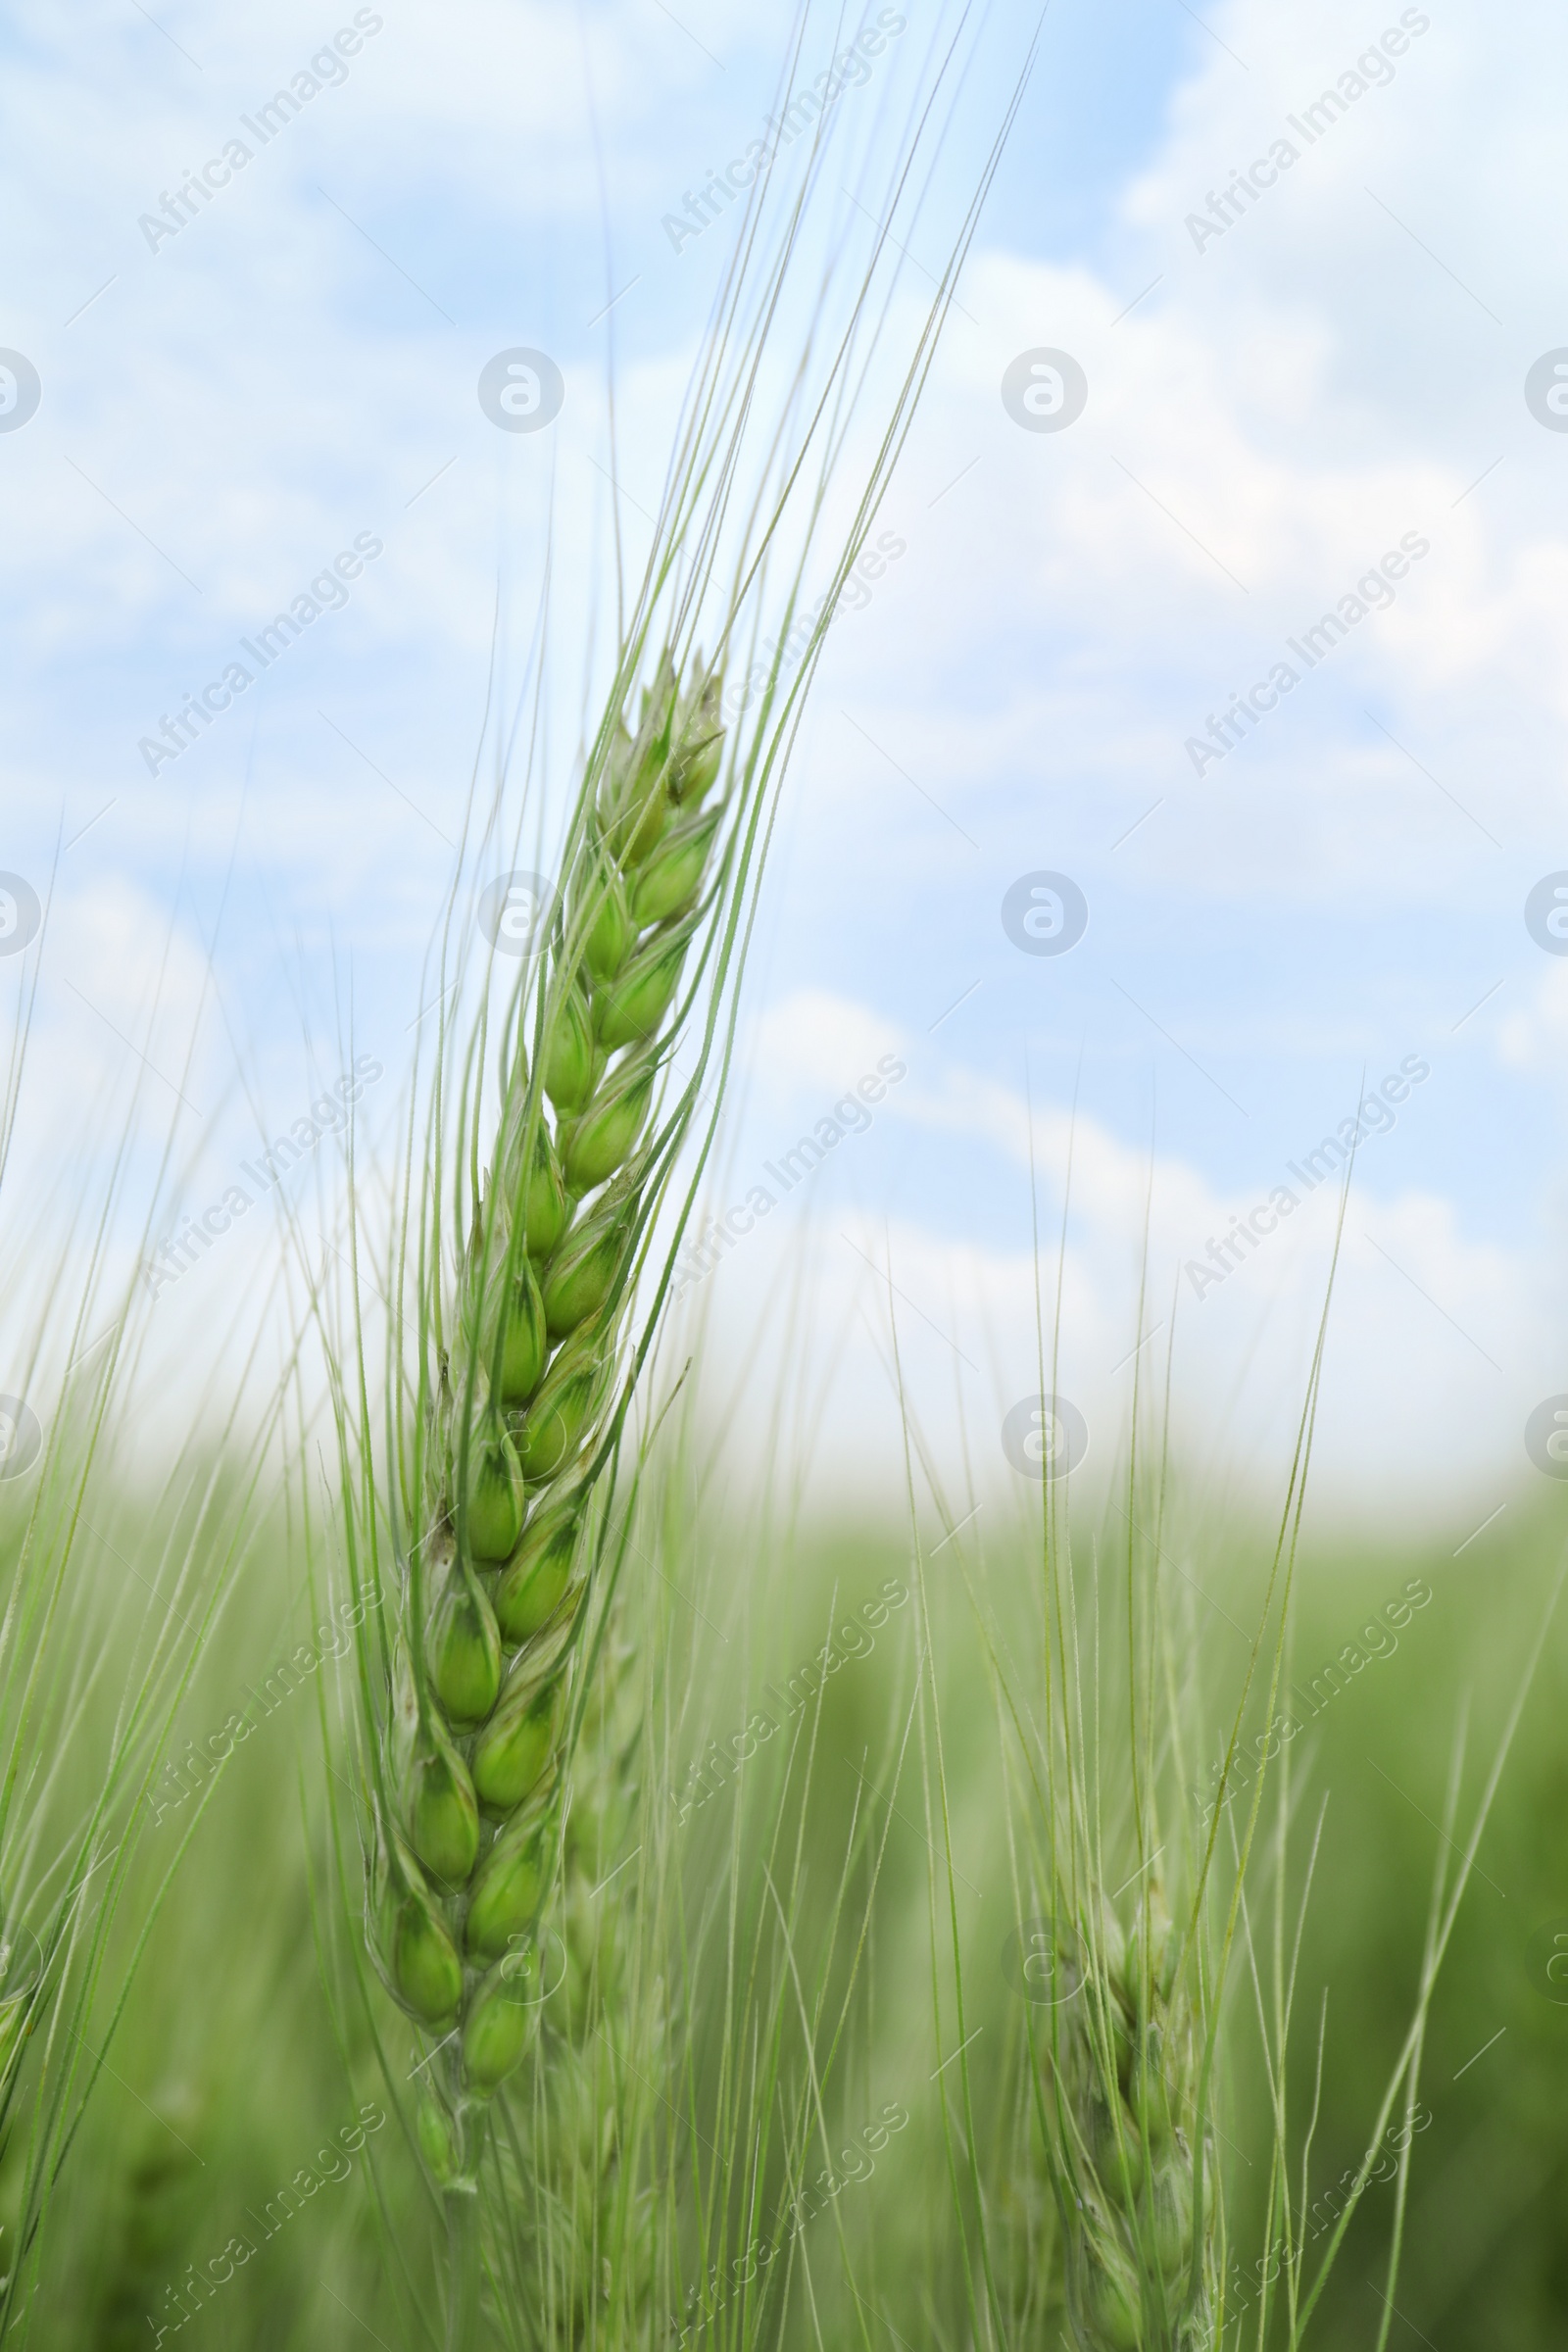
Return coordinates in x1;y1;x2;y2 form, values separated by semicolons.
369;657;724;2154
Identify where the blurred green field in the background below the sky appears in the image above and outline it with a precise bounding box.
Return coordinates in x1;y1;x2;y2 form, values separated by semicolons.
15;1430;1568;2352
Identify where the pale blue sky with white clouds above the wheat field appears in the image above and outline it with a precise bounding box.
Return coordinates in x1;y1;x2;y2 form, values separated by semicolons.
0;0;1568;1564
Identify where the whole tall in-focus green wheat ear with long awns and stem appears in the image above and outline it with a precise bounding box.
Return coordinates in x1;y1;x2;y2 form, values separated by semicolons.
305;14;1044;2352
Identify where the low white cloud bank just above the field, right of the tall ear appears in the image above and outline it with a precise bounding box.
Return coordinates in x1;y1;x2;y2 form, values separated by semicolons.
676;990;1556;1519
